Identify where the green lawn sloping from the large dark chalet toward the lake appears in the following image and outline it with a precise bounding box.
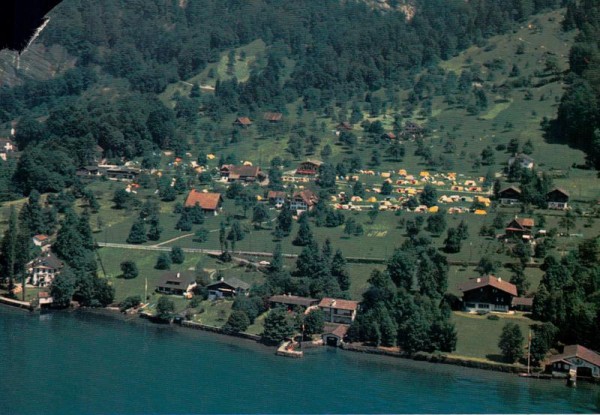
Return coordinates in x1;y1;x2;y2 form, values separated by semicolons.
452;312;533;362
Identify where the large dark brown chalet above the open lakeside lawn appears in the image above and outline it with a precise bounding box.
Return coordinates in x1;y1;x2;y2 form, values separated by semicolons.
458;275;517;312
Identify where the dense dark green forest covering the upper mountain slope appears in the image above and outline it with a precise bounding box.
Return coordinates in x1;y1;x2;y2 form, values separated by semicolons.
0;0;562;199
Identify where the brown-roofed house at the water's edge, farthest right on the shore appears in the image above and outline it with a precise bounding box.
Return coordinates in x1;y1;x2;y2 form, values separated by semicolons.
546;344;600;377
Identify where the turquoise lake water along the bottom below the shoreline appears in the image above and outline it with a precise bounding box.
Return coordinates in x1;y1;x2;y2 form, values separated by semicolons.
0;307;600;414
